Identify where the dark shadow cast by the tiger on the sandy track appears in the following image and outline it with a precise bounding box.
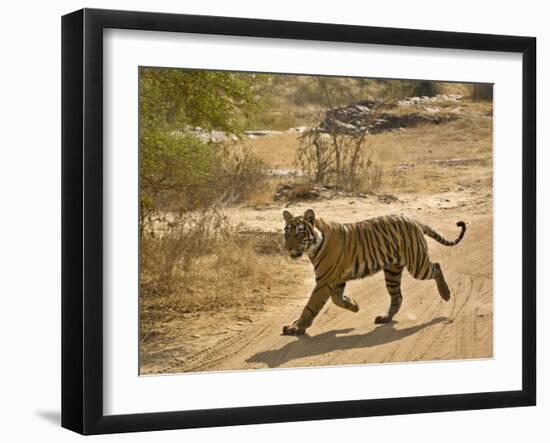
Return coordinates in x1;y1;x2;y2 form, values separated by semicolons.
246;317;451;368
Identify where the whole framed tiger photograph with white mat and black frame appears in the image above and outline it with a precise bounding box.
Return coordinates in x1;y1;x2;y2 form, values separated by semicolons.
62;9;536;434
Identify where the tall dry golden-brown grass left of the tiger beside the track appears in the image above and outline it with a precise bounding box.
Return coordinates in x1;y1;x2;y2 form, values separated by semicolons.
140;211;293;348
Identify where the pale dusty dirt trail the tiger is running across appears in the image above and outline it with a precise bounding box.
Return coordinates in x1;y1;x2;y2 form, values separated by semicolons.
150;196;493;372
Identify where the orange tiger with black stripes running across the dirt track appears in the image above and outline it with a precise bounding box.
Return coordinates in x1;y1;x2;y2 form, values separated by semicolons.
283;209;466;335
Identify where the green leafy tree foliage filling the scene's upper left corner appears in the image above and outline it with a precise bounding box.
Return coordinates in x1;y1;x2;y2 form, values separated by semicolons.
139;67;265;233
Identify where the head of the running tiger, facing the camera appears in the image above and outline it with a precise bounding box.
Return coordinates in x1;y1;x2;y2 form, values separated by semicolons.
283;209;322;259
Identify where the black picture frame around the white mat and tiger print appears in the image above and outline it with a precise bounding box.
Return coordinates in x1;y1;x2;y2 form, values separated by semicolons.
62;9;536;434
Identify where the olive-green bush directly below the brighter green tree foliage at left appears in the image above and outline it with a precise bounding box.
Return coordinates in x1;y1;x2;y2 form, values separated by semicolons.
139;139;267;235
